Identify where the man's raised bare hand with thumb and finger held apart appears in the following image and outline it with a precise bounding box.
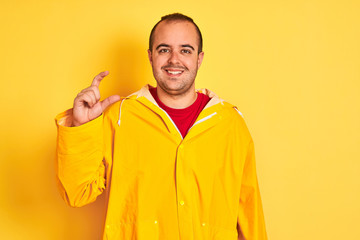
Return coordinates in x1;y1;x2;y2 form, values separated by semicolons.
72;71;120;126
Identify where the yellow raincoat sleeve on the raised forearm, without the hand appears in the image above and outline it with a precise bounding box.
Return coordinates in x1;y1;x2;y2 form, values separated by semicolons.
55;109;106;207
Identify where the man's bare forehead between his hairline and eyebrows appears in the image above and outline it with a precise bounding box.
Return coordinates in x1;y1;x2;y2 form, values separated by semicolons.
154;21;199;48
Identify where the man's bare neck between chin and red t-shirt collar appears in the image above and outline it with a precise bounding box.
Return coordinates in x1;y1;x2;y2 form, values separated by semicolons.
156;86;197;109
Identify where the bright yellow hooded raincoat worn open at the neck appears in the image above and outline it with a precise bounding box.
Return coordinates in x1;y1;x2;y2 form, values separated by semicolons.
56;86;267;240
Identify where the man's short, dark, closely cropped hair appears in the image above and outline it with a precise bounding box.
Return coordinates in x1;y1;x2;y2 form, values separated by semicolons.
149;13;203;53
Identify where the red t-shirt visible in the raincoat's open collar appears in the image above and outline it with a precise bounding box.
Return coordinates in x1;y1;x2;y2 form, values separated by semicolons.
149;88;210;138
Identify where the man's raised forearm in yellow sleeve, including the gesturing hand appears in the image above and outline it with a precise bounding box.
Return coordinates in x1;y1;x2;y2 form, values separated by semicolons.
56;72;120;207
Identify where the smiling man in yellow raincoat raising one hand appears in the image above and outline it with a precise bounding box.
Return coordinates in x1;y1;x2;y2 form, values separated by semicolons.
56;14;267;240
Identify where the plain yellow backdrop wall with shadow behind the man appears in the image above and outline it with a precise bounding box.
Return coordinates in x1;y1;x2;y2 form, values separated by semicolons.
0;0;360;240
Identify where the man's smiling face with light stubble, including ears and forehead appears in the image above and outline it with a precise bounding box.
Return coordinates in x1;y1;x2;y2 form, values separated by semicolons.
148;21;204;95
